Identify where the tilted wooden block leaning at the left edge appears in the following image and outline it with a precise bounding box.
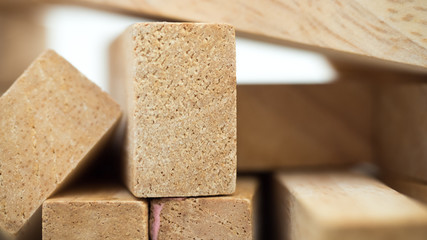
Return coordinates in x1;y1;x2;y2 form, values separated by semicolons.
0;50;121;238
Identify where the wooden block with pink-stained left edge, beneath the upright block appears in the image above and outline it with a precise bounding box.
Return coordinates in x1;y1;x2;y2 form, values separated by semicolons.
150;178;258;240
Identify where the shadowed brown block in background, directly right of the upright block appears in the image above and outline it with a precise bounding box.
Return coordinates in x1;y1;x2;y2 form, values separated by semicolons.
237;81;374;171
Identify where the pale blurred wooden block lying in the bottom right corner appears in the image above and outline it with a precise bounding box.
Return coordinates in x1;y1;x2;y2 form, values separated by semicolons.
274;172;427;240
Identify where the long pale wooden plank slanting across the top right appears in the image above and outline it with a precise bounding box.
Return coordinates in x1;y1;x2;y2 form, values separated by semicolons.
49;0;427;73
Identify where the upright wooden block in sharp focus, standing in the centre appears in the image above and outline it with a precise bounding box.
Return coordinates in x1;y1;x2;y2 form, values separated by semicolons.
111;23;237;197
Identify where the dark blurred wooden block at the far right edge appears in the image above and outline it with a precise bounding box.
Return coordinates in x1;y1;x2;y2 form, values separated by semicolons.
376;82;427;181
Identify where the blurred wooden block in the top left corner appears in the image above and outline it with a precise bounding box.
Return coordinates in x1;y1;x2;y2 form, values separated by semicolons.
0;5;46;95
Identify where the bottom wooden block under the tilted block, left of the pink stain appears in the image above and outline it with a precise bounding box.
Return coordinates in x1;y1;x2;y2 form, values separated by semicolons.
43;184;148;240
